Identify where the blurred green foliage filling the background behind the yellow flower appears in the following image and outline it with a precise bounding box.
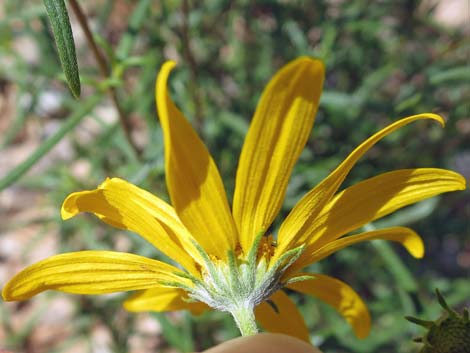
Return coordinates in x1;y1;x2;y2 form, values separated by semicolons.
0;0;470;353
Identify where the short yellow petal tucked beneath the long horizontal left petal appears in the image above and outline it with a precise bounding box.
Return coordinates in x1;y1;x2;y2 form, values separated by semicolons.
124;287;210;315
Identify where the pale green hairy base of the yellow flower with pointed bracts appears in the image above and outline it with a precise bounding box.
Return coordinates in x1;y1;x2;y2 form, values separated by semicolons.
169;232;304;334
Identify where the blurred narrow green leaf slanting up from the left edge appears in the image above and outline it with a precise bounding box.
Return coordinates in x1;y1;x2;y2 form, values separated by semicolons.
0;95;101;191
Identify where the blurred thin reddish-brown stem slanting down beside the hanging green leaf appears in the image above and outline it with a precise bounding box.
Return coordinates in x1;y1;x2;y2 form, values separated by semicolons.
69;0;142;156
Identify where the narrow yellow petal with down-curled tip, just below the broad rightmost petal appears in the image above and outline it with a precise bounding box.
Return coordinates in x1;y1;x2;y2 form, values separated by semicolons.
292;227;424;275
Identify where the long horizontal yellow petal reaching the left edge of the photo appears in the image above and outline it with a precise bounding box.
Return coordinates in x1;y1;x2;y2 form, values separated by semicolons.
2;251;190;301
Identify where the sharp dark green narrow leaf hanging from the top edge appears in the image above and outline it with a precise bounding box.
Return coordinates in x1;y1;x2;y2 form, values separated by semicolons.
43;0;81;98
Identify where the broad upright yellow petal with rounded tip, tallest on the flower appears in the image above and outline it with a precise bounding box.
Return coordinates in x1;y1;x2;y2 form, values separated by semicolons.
233;57;324;252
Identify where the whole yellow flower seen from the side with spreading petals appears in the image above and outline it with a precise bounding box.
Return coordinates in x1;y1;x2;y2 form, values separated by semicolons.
2;57;465;340
